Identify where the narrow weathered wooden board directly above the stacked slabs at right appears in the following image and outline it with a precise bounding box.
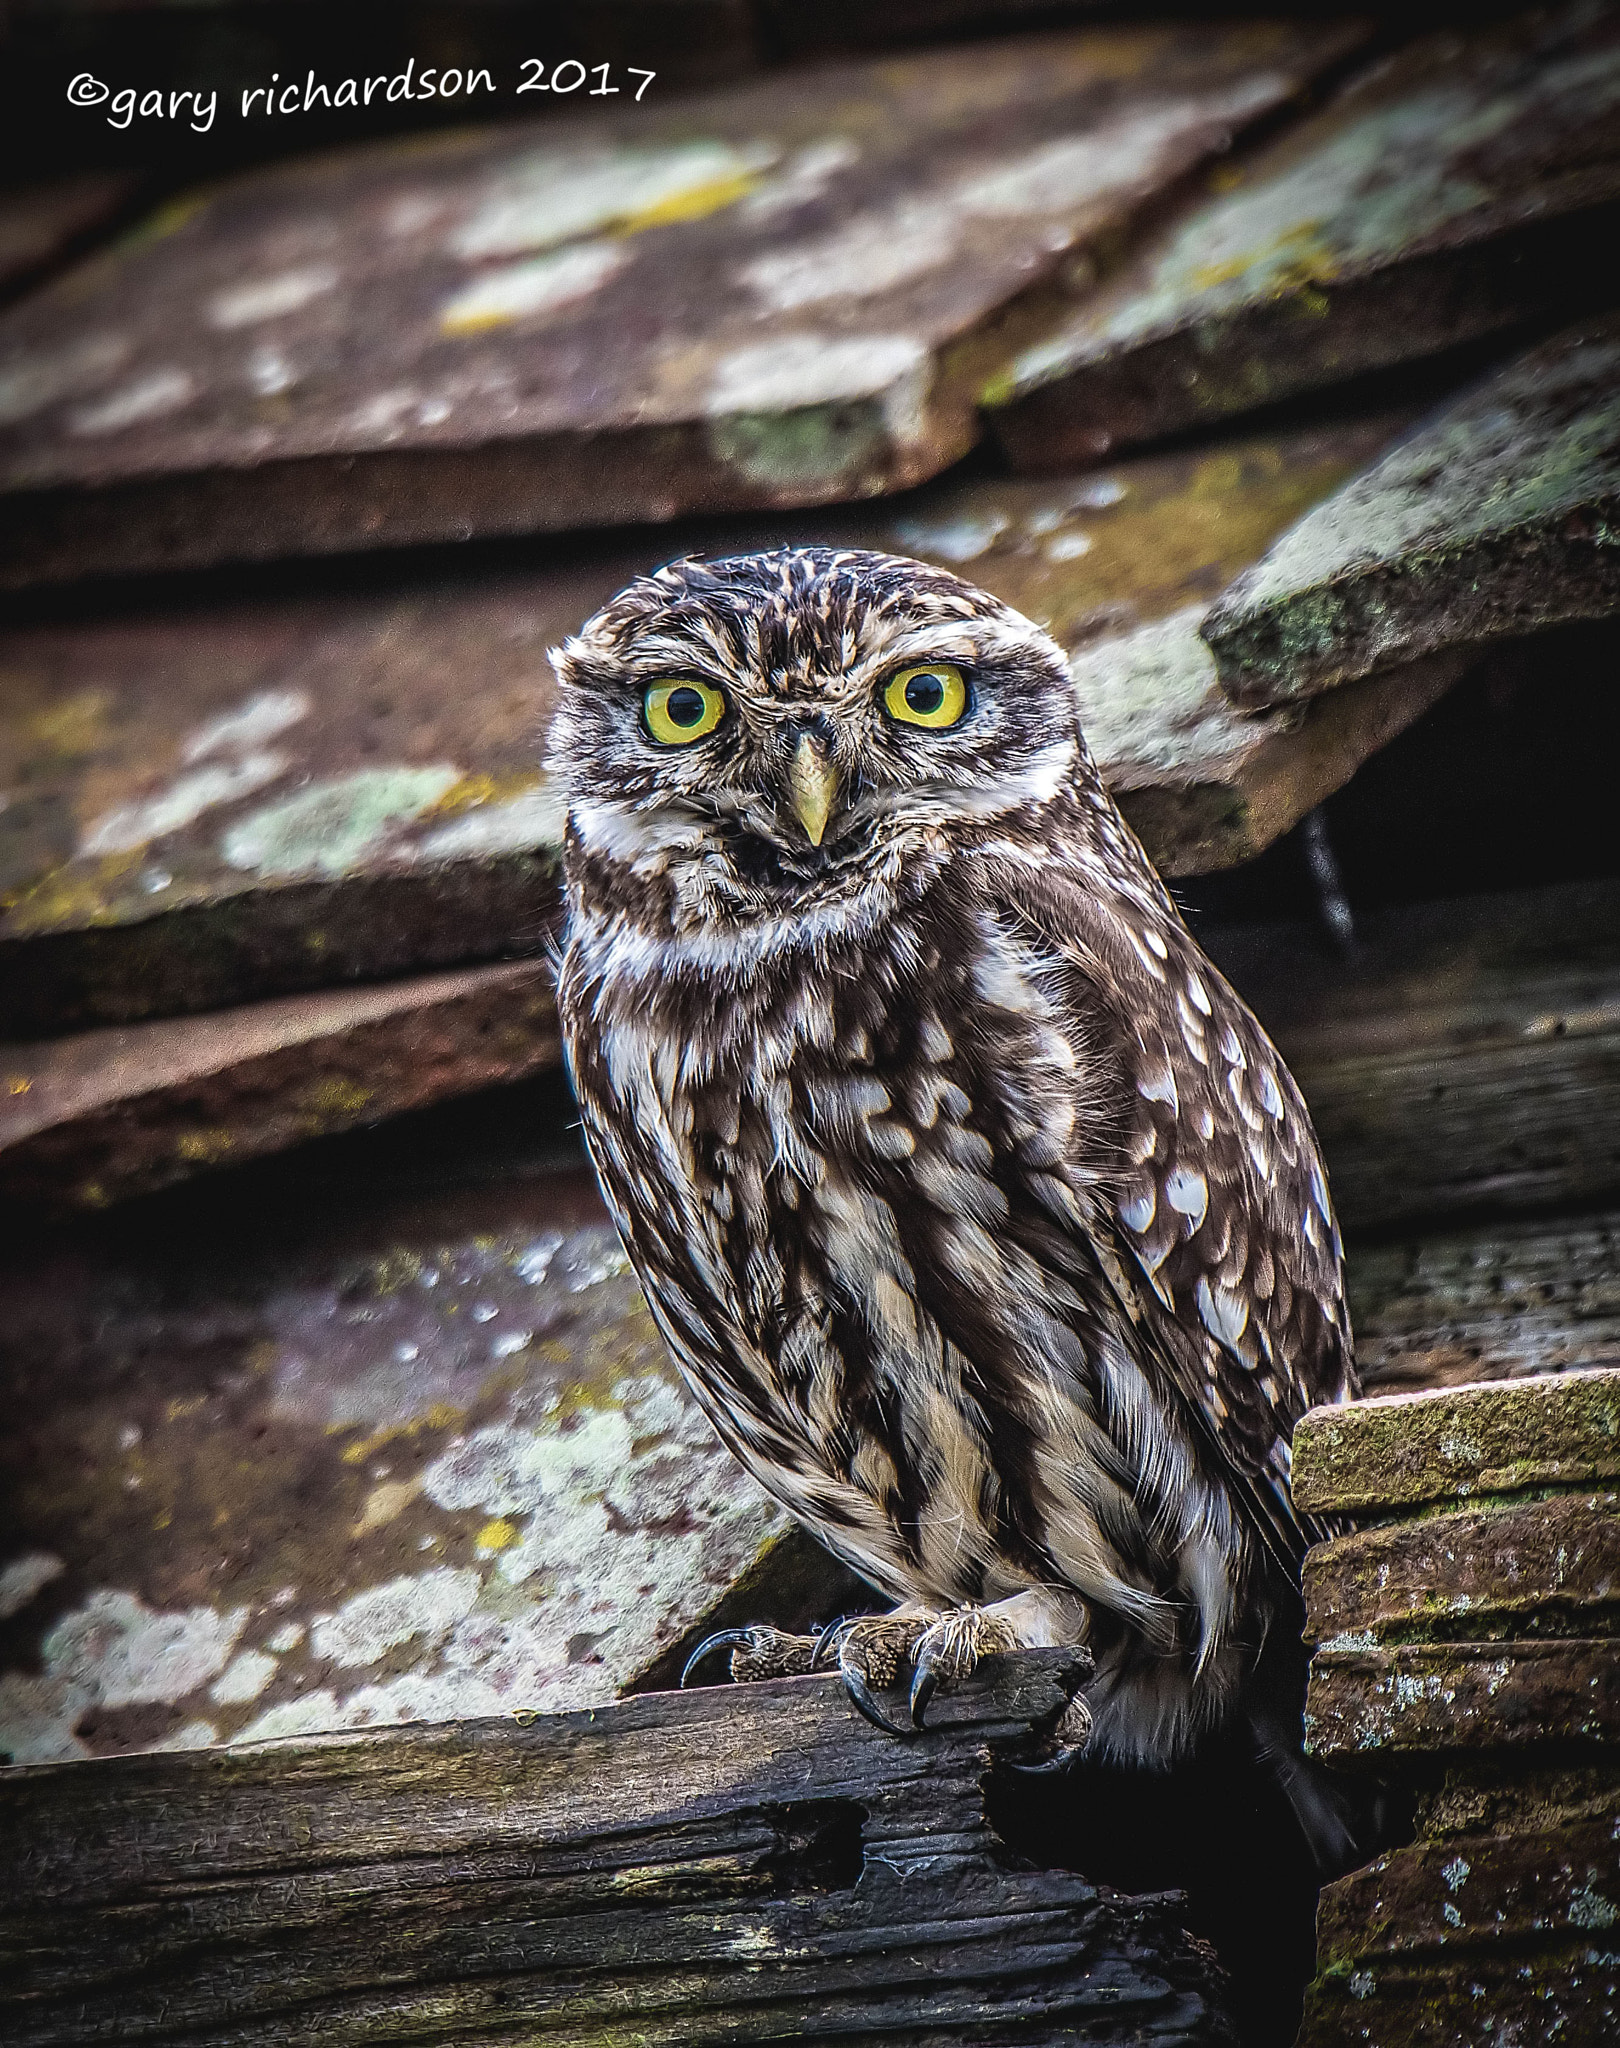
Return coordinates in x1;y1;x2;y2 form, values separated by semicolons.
1348;1212;1620;1395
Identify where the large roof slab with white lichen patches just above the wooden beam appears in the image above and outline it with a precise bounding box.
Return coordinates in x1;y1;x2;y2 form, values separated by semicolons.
0;1146;870;1769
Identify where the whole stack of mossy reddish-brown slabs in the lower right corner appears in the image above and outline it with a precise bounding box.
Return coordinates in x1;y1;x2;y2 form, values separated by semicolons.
1294;1368;1620;2048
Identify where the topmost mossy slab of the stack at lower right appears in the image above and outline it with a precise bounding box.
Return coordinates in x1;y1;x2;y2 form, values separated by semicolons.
1294;1368;1620;1516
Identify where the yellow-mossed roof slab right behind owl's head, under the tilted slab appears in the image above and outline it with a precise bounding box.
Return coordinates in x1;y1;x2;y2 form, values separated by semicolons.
872;414;1462;874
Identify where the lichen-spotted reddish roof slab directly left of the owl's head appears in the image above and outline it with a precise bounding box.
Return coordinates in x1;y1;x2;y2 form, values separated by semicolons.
0;563;581;1038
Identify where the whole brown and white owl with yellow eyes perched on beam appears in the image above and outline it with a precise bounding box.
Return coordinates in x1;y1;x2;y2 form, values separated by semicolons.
549;547;1356;1867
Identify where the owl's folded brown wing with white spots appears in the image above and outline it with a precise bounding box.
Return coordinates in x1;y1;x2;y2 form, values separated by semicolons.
991;839;1354;1559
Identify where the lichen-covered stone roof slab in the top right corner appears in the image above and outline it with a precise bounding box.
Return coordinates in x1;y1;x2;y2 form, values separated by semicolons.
987;6;1620;469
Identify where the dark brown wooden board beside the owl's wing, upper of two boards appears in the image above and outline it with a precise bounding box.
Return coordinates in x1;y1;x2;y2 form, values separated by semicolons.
1208;881;1620;1229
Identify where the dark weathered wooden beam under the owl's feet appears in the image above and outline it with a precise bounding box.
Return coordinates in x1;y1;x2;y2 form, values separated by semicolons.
0;1651;1233;2048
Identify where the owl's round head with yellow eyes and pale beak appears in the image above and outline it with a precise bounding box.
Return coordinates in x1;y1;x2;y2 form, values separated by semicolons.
549;547;1090;936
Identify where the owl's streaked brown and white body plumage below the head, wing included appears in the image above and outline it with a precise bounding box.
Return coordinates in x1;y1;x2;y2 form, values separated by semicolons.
559;782;1352;1657
